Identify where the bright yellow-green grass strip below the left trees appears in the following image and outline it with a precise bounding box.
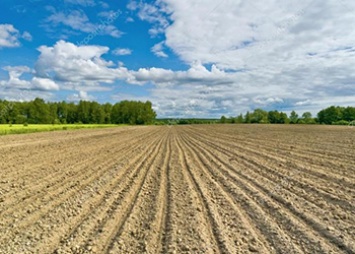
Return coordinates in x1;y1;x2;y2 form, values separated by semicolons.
0;124;124;135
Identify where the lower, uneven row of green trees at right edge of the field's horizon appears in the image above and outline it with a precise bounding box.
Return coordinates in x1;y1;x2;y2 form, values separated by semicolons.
220;106;355;125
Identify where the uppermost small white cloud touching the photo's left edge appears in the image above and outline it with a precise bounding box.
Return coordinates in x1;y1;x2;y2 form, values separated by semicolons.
0;24;32;48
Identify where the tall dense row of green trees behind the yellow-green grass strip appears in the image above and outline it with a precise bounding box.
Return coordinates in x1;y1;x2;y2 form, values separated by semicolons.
0;98;156;124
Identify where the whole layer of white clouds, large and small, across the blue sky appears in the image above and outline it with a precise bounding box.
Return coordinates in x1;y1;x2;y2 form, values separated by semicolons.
0;0;355;117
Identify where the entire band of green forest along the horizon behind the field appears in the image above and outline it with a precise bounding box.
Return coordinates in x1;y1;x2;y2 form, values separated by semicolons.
0;98;355;125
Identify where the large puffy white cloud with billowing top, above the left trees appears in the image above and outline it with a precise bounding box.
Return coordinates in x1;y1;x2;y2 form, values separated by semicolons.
35;40;134;87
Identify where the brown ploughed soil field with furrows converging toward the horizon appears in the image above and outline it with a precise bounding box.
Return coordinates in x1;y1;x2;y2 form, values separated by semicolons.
0;125;355;254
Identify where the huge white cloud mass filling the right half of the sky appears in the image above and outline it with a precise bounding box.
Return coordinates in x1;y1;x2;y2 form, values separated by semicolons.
119;0;355;116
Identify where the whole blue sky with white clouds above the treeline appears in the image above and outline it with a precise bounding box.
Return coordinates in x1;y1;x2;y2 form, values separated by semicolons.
0;0;355;118
